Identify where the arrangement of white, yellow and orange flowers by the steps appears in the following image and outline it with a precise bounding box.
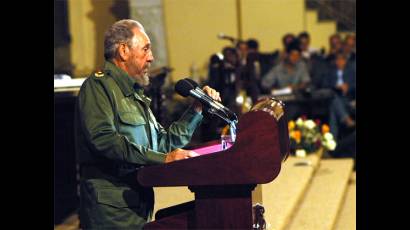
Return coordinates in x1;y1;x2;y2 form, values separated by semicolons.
288;117;336;156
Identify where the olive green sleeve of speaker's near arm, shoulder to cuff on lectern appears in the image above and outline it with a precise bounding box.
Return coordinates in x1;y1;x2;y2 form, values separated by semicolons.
78;77;166;165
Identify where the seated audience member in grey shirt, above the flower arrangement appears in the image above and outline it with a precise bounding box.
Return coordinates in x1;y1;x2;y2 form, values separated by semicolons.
262;39;310;91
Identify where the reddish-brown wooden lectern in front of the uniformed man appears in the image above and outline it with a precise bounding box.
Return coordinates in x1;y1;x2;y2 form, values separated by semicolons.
138;98;289;229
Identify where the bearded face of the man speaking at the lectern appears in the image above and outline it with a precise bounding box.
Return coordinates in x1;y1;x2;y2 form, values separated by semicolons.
125;28;154;86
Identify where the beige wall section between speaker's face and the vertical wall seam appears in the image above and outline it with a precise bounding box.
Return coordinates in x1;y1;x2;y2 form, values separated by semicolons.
163;0;238;81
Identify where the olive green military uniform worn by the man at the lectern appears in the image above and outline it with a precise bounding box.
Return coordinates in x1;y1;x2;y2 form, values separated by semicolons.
76;62;202;229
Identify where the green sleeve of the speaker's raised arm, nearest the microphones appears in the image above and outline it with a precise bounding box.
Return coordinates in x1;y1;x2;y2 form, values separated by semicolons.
158;106;203;152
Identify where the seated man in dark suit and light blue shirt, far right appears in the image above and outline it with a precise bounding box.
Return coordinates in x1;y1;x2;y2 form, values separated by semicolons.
323;53;356;138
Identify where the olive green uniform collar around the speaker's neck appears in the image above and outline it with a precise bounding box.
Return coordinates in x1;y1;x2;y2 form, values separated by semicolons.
104;61;144;96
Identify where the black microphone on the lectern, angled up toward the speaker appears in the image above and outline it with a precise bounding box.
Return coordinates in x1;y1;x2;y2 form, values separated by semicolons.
175;78;238;123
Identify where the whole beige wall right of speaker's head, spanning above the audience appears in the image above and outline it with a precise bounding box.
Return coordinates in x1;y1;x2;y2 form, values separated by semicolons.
164;0;336;81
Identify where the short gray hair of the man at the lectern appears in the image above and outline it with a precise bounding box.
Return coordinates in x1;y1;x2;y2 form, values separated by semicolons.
104;19;144;60
